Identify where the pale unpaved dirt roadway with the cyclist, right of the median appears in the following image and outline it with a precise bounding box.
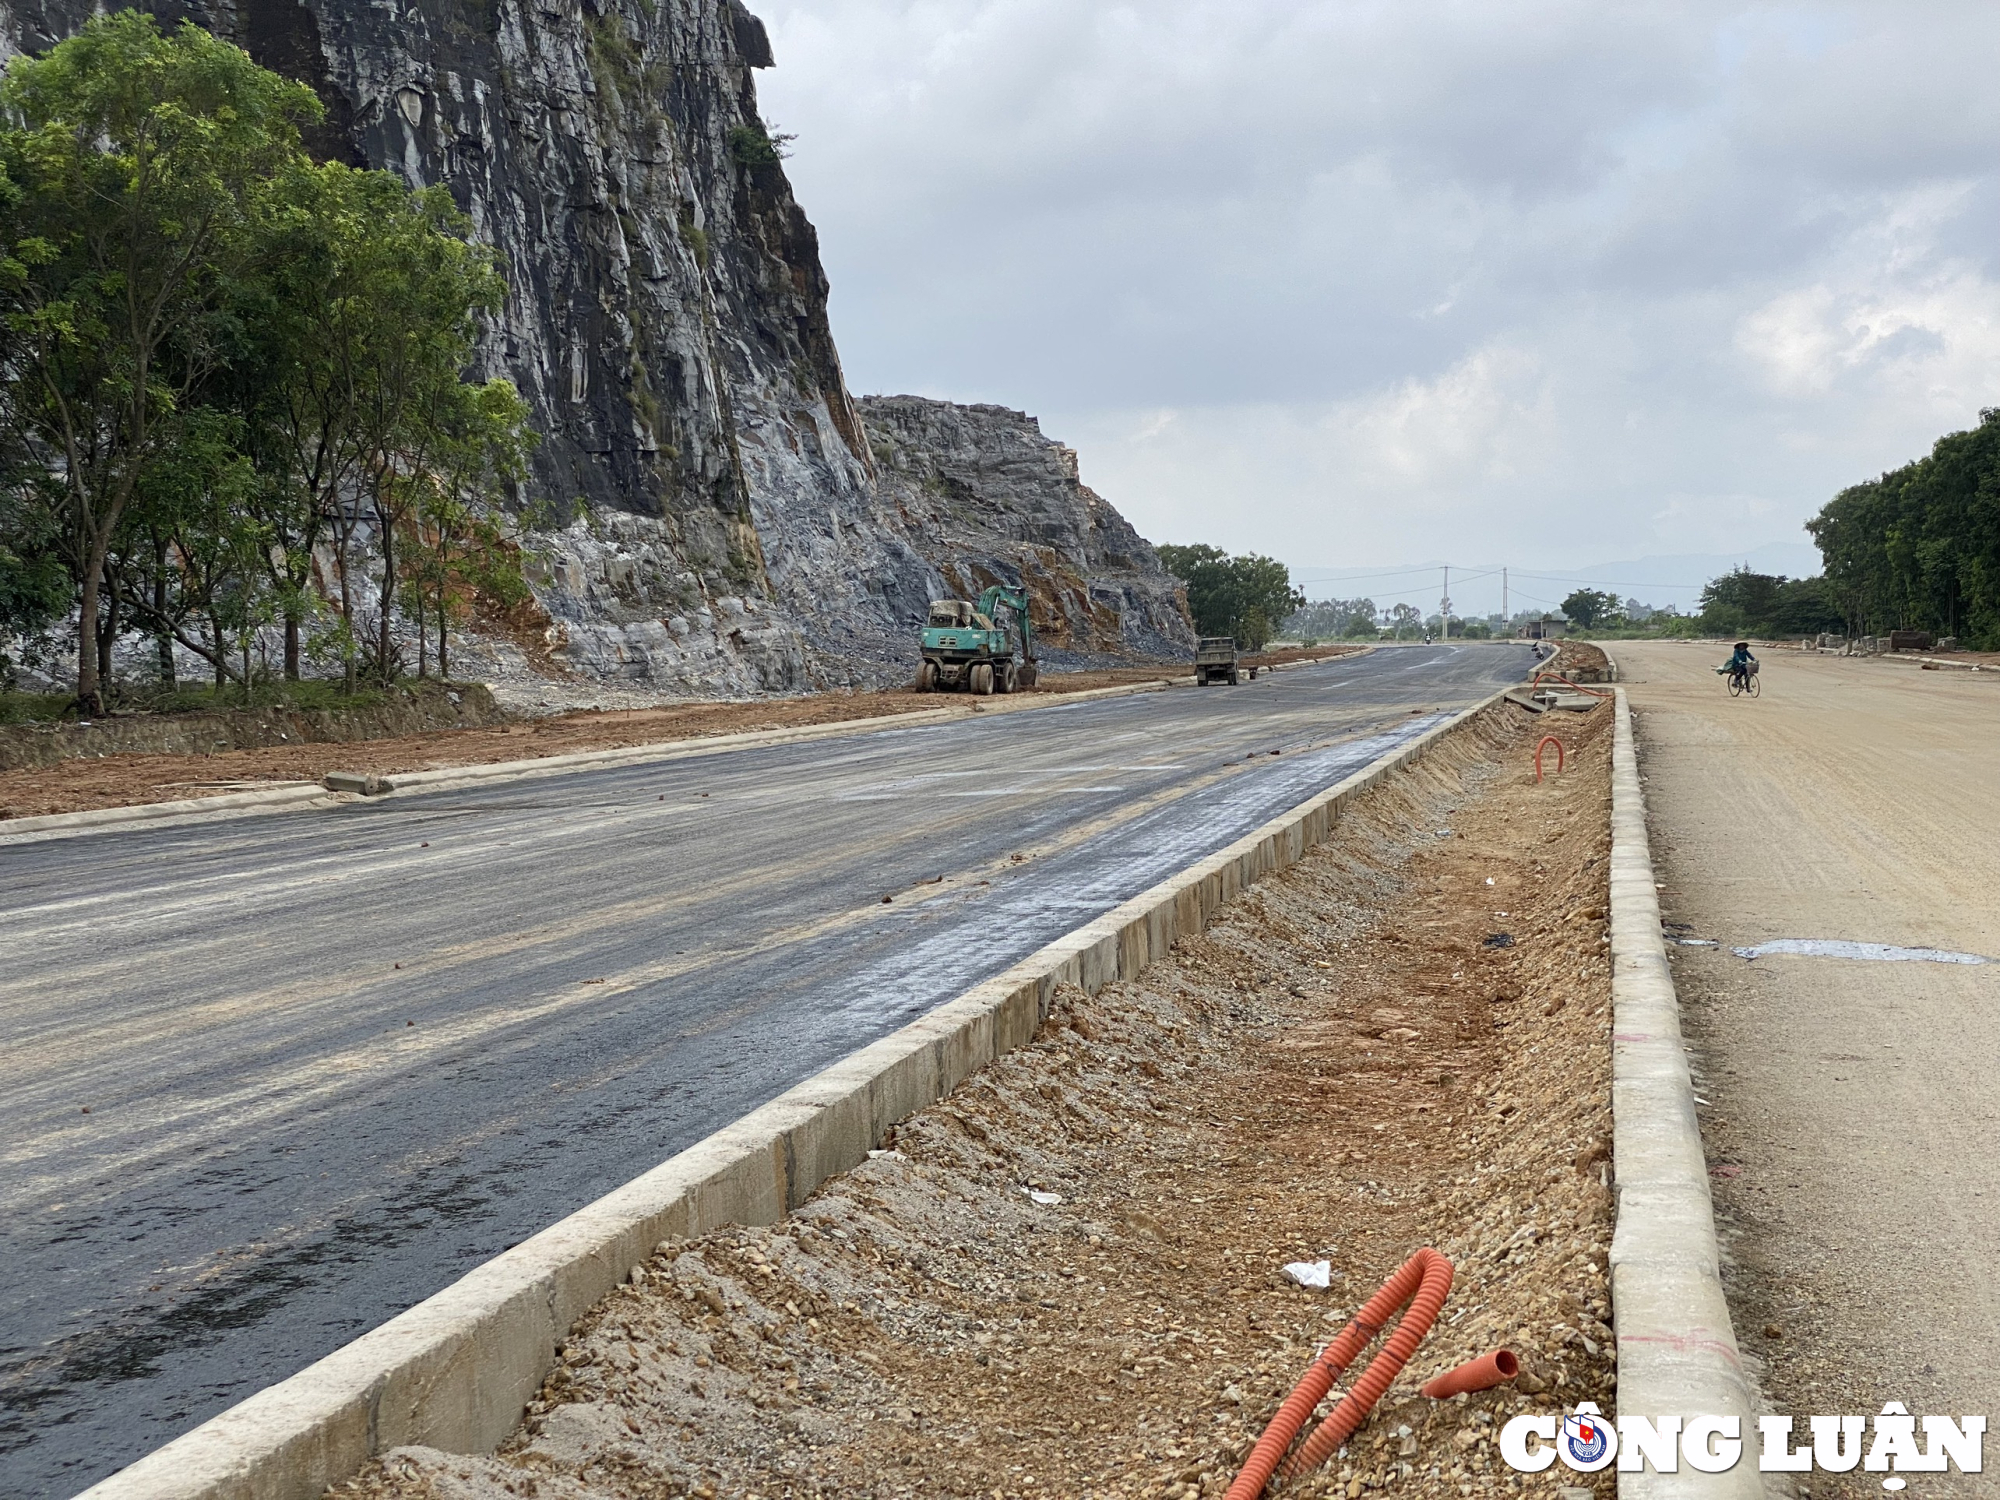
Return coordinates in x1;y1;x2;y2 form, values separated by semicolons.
1616;644;2000;1496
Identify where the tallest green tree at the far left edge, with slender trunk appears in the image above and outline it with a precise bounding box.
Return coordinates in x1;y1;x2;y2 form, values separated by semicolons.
0;10;320;712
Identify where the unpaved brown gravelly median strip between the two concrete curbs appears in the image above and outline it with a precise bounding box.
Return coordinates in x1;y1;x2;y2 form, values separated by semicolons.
336;708;1614;1500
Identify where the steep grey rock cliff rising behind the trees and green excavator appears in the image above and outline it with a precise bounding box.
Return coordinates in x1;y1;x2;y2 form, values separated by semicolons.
0;0;1188;694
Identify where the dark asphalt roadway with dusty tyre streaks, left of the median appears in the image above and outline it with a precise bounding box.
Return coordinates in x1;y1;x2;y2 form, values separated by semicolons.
0;646;1530;1500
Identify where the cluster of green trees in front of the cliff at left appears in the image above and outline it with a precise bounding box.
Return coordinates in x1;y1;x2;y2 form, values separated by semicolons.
0;10;534;712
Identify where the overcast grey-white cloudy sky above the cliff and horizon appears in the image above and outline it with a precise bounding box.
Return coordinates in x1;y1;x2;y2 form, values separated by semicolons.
754;0;2000;592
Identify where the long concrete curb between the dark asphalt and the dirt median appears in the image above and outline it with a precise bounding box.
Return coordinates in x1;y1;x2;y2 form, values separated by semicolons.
80;692;1502;1500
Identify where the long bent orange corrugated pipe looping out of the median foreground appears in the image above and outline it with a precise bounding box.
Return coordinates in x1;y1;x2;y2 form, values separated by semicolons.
1228;1246;1452;1500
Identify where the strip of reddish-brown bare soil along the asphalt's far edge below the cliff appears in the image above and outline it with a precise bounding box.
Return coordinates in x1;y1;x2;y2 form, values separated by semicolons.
0;646;1356;820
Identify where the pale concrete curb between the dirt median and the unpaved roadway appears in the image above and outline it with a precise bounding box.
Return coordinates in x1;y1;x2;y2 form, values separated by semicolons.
1612;688;1762;1500
